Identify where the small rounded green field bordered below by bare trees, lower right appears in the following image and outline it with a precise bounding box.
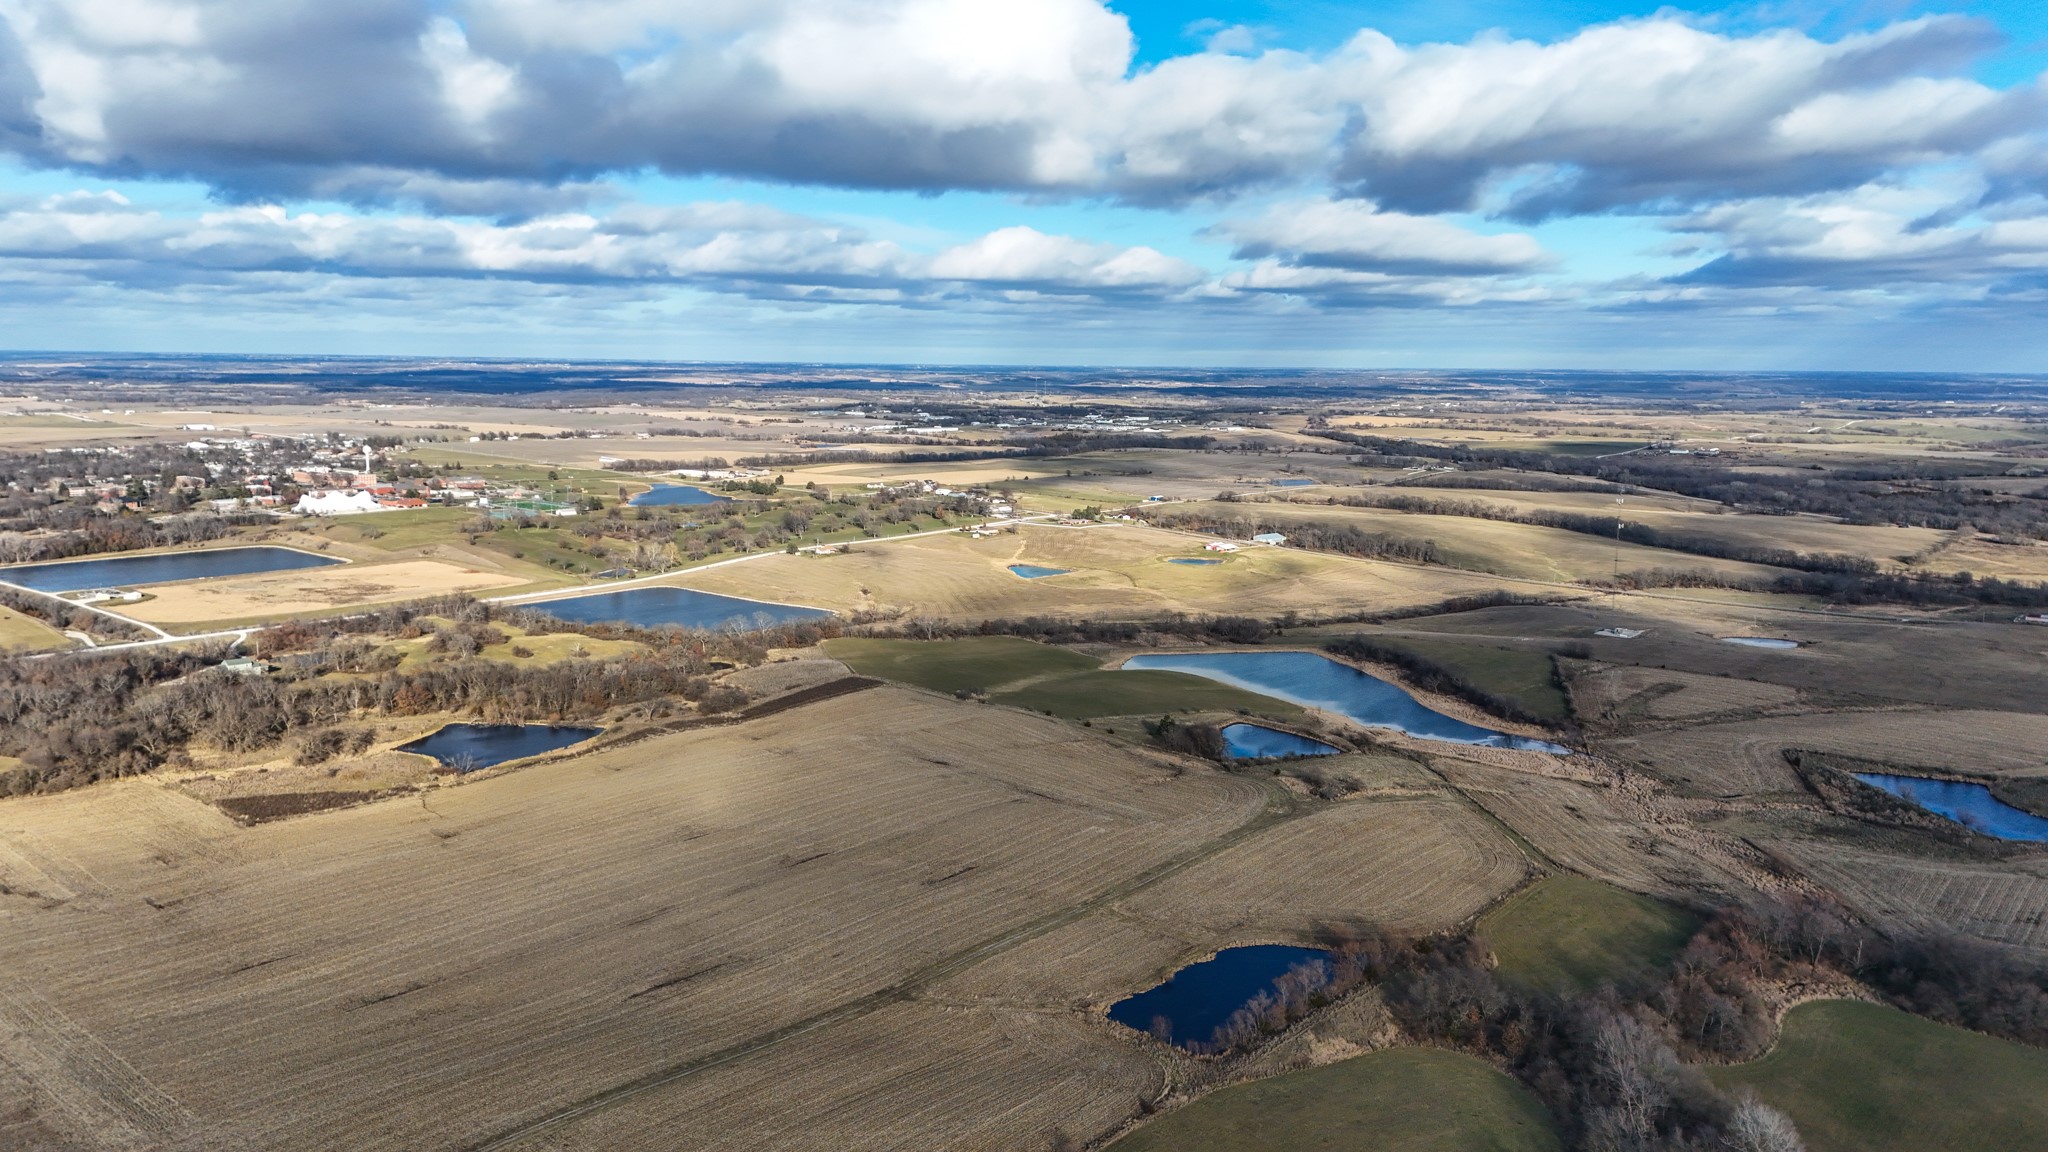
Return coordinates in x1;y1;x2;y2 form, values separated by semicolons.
1479;875;1700;992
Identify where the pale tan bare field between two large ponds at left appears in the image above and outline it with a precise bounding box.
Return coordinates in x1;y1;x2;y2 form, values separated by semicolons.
123;560;526;623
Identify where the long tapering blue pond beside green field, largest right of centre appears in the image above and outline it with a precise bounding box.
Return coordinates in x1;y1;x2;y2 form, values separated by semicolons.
1124;652;1571;756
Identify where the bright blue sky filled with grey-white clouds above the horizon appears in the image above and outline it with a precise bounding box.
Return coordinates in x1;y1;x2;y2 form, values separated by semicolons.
0;0;2048;373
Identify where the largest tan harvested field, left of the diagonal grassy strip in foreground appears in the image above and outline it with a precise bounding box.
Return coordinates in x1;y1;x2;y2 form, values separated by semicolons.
0;689;1268;1150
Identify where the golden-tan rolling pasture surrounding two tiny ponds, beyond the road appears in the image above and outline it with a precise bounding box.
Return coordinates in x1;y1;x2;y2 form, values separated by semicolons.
686;527;1497;619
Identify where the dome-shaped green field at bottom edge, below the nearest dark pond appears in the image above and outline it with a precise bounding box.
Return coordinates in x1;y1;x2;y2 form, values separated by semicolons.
1112;1047;1559;1152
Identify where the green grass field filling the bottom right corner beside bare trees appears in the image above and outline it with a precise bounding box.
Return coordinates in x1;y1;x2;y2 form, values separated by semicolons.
1708;1000;2048;1152
